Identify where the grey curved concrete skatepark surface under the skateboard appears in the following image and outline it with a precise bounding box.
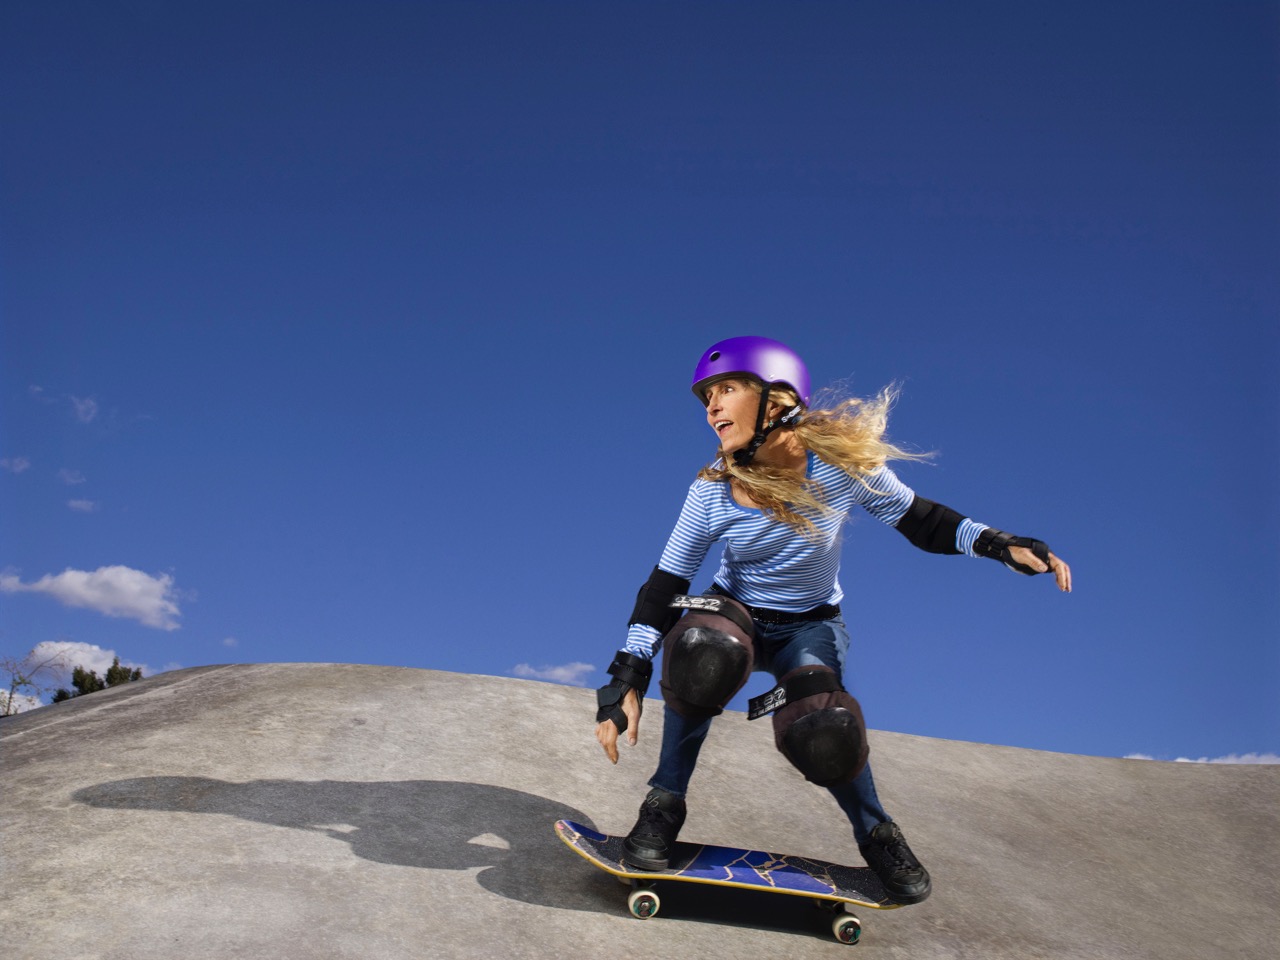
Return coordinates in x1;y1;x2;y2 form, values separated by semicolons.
0;664;1280;960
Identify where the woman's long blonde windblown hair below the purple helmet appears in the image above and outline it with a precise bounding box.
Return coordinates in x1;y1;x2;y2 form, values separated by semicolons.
698;378;929;536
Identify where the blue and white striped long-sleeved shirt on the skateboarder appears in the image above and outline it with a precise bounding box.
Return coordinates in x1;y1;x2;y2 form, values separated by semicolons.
625;453;986;658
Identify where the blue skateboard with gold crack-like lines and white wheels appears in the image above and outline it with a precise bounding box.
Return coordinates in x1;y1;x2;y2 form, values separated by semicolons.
556;820;901;943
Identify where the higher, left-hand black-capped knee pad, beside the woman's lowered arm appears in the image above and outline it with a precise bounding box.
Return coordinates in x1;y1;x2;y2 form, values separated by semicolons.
660;598;754;718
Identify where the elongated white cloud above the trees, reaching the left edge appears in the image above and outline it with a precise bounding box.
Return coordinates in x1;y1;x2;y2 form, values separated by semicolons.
0;566;182;630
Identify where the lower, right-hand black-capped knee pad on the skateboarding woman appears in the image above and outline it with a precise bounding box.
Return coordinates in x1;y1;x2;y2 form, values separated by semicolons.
773;667;869;787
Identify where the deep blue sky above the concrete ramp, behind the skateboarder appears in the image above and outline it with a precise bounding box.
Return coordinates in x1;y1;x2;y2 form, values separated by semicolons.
0;0;1280;759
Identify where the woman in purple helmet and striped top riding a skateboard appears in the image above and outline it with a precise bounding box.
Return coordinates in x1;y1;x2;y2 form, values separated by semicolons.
595;337;1071;904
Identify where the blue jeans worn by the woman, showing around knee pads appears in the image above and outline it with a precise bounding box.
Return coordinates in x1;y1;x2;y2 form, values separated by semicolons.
649;617;890;844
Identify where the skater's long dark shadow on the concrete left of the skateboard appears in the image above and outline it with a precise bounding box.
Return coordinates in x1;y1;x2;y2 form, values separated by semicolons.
72;777;608;910
